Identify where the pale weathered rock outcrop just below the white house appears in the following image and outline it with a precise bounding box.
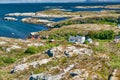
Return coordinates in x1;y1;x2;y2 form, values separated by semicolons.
46;46;93;57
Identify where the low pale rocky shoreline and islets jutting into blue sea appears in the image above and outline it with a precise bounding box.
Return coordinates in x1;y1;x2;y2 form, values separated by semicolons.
1;5;120;39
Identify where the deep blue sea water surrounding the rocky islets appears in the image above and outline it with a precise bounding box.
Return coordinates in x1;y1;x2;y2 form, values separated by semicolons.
0;3;119;39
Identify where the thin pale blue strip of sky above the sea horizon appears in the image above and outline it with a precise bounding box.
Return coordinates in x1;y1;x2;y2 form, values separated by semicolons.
0;0;120;3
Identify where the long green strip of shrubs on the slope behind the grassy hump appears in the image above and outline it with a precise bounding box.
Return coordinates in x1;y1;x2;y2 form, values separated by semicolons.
54;16;120;27
